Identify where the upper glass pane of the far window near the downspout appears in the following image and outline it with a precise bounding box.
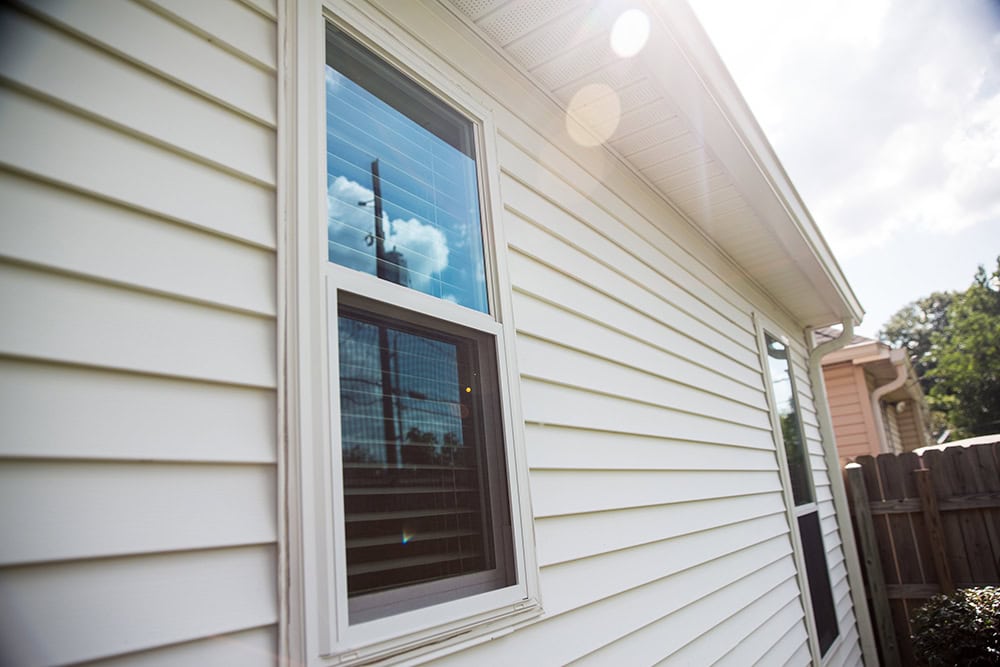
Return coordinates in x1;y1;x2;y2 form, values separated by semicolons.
765;334;813;505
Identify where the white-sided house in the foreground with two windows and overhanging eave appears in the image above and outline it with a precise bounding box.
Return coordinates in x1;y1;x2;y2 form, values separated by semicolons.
0;0;876;665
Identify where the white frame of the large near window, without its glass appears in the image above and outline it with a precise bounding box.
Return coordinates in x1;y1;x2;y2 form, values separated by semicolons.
279;0;541;665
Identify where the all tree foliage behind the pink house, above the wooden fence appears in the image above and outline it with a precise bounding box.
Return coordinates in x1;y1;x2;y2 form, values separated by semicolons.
879;257;1000;437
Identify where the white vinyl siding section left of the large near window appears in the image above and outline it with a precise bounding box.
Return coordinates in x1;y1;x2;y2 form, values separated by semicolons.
0;0;278;665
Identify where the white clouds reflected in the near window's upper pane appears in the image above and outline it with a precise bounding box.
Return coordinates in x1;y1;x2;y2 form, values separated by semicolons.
327;176;448;292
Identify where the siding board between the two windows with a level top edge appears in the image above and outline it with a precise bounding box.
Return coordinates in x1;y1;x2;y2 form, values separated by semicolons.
531;470;781;516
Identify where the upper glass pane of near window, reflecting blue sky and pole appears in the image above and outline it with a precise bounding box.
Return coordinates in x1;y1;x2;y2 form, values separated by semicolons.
326;26;488;312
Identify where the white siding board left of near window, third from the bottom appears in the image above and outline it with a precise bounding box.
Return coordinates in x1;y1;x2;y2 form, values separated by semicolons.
0;461;277;565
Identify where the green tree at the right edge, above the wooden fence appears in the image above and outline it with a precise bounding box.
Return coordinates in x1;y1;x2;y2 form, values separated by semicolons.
927;257;1000;437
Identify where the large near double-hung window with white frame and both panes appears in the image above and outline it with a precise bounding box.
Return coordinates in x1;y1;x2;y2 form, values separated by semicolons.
290;7;538;664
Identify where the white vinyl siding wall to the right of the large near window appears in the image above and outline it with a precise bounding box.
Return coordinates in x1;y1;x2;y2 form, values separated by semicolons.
364;2;860;665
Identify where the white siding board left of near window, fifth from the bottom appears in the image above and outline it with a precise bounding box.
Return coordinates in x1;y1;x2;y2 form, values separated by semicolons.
0;264;277;387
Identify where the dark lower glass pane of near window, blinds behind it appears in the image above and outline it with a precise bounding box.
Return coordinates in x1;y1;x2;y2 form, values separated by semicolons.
338;307;511;620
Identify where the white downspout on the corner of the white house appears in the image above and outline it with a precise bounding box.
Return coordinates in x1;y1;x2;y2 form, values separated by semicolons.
806;318;879;665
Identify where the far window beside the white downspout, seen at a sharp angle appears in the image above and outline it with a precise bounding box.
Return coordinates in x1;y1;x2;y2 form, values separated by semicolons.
764;332;839;655
